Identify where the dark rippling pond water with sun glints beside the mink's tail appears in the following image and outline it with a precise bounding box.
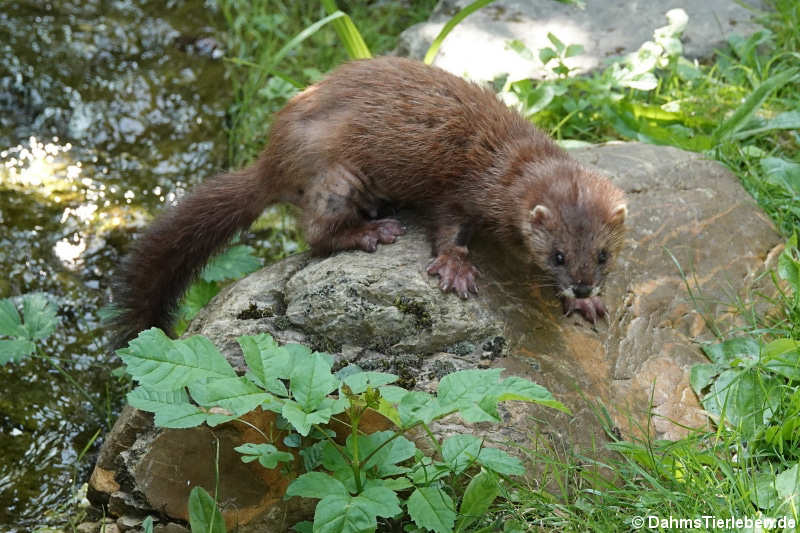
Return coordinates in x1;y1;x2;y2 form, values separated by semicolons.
0;0;230;532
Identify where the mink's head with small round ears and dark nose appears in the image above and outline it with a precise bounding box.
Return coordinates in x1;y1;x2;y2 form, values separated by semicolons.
524;160;628;298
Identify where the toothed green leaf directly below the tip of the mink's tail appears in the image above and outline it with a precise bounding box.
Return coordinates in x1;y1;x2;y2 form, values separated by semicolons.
117;328;236;390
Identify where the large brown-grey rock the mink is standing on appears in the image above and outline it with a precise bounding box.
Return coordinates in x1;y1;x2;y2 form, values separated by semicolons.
93;143;780;532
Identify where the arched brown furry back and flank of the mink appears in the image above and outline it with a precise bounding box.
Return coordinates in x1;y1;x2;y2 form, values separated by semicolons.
270;57;563;203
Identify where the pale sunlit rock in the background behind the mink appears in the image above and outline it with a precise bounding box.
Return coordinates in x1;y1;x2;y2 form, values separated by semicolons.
398;0;765;80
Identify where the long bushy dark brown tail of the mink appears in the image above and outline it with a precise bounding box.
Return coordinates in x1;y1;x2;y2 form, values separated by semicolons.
112;159;277;347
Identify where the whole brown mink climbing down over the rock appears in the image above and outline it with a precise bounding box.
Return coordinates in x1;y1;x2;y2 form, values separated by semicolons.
114;57;626;342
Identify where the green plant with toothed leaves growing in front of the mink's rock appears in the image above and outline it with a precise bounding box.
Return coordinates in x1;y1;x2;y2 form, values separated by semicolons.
117;329;566;532
